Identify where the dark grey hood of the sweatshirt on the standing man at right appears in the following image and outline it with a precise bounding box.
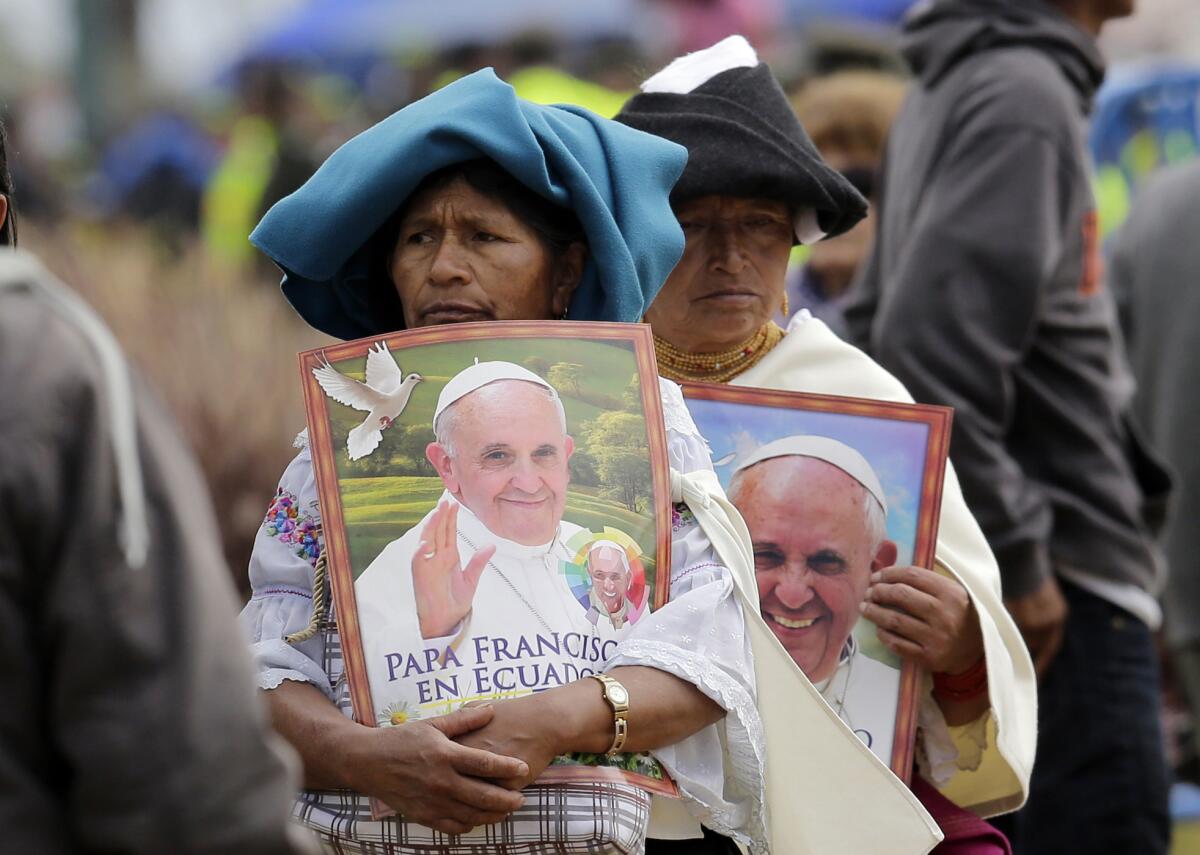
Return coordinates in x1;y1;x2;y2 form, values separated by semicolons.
900;0;1104;108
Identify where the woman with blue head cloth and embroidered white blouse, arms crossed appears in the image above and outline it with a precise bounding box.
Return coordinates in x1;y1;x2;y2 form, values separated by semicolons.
242;71;766;853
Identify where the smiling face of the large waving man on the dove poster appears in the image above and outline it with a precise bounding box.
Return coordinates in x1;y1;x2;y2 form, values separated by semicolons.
426;381;575;546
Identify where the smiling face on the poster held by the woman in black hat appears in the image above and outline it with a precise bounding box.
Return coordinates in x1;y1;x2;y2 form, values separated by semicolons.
730;456;896;682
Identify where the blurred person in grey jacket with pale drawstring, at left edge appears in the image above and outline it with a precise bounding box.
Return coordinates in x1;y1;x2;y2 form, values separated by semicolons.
0;123;316;855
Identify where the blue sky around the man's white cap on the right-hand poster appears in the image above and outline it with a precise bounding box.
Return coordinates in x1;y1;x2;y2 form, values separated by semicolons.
688;399;929;564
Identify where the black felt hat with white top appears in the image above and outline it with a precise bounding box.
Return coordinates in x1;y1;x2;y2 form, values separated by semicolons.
616;36;866;244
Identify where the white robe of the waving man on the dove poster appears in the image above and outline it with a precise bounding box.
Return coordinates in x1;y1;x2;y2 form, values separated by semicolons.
354;492;628;719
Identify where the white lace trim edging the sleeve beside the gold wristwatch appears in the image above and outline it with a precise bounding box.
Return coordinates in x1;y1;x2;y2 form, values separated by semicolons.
606;640;768;853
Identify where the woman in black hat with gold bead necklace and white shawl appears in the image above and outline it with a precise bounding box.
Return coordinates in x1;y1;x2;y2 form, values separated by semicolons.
617;36;1036;850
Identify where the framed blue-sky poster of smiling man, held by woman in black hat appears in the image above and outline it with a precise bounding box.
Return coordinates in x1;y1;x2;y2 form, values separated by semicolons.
683;383;952;781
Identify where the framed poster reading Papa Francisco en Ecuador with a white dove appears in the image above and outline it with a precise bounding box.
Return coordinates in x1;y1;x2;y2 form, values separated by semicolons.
300;321;674;813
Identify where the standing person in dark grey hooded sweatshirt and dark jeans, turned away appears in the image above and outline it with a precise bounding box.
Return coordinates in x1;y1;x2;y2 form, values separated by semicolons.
846;0;1169;853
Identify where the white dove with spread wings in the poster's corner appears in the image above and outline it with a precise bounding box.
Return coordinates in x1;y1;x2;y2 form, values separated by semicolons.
312;341;424;460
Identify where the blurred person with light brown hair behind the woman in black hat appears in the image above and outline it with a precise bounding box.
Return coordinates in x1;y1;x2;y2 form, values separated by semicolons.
781;71;905;337
